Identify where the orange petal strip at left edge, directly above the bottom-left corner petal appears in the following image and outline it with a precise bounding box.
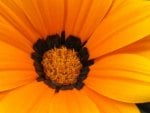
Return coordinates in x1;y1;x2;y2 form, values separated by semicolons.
0;70;37;92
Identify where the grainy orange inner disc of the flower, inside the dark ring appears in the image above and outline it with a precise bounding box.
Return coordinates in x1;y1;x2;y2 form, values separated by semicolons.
42;46;82;85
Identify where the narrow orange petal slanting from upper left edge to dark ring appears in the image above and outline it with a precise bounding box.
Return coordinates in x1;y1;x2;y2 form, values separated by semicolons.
0;23;32;53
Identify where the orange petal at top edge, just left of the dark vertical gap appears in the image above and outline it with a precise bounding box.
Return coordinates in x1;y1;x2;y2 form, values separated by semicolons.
36;0;65;34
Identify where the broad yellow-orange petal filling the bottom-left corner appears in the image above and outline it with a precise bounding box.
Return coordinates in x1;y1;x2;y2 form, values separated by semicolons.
0;81;53;113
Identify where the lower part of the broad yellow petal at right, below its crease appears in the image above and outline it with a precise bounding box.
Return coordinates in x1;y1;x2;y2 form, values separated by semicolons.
86;77;150;103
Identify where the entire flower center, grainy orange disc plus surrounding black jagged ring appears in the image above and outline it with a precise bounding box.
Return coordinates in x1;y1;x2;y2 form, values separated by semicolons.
31;32;94;92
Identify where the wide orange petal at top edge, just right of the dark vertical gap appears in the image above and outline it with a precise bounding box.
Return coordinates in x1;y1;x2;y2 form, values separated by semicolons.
65;0;112;41
